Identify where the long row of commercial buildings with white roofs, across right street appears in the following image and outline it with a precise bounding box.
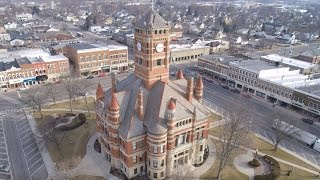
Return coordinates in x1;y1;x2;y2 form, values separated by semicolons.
198;56;320;116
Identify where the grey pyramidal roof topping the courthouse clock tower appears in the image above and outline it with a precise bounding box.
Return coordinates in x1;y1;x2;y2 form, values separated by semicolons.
136;10;169;28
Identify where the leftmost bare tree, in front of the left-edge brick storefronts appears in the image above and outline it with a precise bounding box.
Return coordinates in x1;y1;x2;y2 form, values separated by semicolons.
23;87;47;119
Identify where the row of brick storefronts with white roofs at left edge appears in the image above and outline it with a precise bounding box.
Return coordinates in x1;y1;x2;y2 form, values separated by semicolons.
0;49;69;88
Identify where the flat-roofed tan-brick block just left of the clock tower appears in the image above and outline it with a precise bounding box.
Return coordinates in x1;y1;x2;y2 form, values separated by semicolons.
63;43;128;76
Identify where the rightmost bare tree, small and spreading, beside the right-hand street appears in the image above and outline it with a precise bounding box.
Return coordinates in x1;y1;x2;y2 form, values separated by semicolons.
266;113;299;151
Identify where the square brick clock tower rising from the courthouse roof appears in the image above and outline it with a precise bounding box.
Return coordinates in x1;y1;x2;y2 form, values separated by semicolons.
134;10;170;90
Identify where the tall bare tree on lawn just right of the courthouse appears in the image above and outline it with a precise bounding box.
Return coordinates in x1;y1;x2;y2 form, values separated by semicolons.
217;110;252;179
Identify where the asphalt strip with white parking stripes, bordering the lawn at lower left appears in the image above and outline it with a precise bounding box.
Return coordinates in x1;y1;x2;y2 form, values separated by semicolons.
0;112;48;180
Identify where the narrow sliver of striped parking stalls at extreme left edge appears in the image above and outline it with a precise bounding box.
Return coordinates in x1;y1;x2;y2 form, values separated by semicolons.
0;117;11;179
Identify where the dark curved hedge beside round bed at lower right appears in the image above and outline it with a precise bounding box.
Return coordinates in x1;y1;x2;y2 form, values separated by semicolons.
254;155;280;180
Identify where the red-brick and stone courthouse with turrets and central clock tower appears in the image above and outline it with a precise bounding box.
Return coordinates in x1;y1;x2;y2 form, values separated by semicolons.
96;11;211;179
